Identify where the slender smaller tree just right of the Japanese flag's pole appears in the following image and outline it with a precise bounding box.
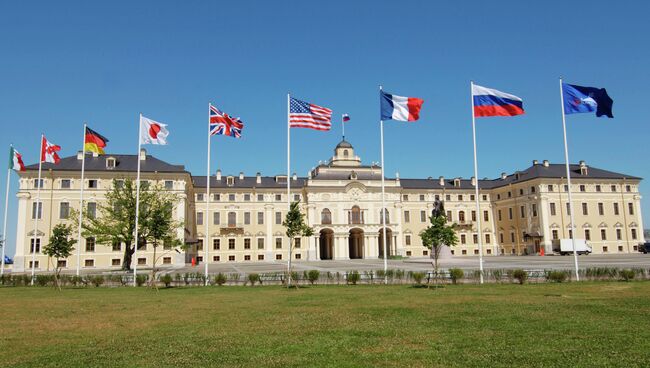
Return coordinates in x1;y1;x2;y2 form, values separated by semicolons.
142;191;182;289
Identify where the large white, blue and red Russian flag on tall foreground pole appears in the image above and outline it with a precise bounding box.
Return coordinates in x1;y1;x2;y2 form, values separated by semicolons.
472;84;524;117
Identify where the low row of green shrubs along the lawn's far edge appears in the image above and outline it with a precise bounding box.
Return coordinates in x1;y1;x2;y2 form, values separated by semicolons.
0;267;650;287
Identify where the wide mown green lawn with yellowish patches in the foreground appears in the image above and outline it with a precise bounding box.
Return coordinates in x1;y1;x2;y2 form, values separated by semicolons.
0;282;650;367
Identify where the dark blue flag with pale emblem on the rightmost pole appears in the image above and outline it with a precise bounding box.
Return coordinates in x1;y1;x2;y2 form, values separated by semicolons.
562;83;614;118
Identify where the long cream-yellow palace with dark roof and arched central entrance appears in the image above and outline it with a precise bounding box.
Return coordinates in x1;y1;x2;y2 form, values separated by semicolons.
14;141;644;271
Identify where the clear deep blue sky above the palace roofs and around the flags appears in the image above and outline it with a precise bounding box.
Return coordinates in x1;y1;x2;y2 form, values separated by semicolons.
0;1;650;253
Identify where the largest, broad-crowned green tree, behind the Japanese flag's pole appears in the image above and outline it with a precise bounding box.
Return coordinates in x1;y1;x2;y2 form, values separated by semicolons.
71;178;168;271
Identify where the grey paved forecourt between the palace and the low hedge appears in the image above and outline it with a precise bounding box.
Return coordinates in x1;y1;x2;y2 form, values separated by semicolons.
170;254;650;274
